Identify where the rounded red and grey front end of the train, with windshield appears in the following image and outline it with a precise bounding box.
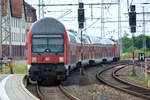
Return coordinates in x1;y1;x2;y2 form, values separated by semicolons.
28;18;68;82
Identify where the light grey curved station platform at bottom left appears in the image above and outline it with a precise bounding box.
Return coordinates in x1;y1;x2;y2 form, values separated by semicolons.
0;75;39;100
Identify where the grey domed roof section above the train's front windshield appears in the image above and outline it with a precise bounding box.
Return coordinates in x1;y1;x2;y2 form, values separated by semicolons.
31;17;64;35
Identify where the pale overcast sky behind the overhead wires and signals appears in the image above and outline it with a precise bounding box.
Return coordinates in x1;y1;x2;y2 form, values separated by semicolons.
25;0;150;39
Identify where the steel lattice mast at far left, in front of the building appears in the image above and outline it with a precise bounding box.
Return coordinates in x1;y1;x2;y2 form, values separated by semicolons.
1;0;13;74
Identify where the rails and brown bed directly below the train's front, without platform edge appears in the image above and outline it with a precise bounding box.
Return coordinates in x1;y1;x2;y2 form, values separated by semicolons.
36;85;80;100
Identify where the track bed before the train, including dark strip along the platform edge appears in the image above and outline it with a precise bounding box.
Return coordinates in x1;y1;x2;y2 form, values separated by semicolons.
23;76;80;100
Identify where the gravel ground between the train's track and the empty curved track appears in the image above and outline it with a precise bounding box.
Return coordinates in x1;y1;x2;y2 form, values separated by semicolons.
63;63;144;100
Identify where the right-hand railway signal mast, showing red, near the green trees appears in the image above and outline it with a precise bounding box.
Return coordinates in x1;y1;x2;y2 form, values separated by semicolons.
129;5;136;75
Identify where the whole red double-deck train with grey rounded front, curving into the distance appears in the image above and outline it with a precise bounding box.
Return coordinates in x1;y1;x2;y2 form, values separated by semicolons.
28;17;120;82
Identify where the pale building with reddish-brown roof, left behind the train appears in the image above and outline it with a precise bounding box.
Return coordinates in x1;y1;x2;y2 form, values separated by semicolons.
2;0;36;59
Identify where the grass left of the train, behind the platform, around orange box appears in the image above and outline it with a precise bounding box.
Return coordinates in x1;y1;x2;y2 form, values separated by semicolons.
0;62;27;74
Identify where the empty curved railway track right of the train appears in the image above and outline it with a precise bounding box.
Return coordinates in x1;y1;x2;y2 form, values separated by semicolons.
96;63;150;100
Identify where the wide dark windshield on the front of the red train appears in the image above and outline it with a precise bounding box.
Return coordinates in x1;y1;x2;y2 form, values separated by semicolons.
32;35;64;54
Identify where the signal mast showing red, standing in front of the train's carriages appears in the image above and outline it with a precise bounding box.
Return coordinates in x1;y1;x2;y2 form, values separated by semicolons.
78;2;85;74
